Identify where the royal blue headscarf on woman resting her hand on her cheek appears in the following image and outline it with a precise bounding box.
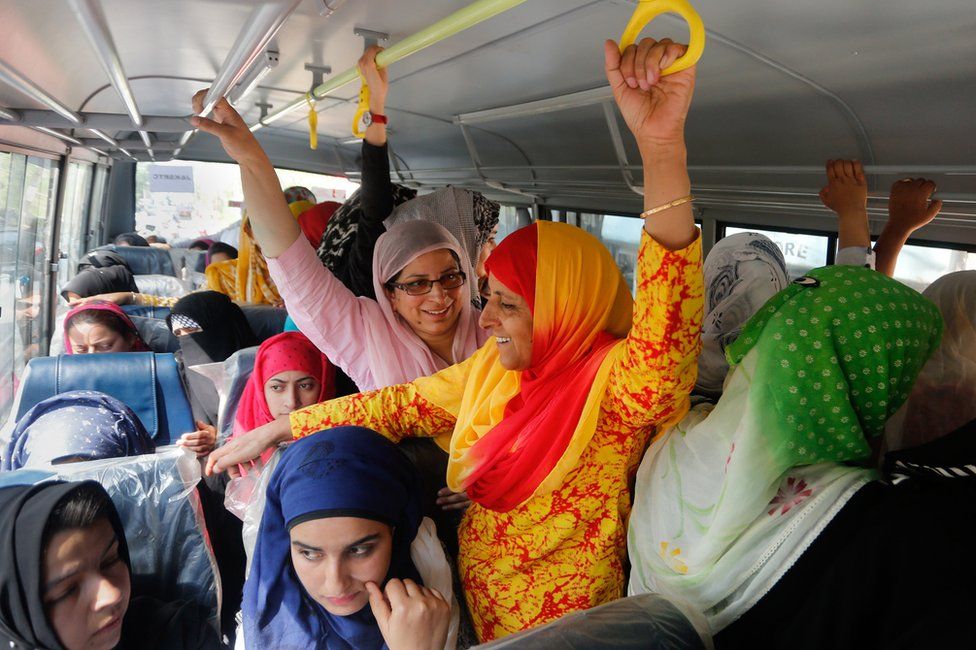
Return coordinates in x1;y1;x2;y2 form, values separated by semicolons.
243;427;423;650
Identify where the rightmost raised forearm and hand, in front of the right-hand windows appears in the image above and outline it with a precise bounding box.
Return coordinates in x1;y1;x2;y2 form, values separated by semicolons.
874;178;942;277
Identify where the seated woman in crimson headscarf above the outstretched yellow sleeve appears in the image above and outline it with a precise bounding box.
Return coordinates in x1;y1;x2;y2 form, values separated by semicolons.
231;332;335;461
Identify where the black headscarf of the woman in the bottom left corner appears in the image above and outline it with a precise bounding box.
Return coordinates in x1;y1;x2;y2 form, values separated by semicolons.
0;481;129;650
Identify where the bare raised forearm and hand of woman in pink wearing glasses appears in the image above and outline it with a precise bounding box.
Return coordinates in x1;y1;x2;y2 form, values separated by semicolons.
190;90;302;258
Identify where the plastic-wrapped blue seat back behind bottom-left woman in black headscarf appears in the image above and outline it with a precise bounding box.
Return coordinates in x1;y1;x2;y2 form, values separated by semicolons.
2;446;220;627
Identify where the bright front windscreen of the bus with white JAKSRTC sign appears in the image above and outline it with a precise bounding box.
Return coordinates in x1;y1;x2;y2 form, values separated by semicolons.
135;160;359;243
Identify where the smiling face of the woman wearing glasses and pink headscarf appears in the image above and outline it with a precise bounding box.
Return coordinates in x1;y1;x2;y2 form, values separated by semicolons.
386;248;466;338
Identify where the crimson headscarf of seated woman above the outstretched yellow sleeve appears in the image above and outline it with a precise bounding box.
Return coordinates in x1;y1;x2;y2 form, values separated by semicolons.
231;332;335;461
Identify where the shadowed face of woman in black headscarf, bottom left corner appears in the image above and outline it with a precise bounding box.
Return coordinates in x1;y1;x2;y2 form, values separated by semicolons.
41;519;130;650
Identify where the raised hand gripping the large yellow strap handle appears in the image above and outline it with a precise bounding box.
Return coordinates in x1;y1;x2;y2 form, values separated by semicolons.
603;38;695;151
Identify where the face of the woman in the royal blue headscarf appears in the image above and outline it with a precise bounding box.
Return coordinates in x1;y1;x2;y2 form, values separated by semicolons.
291;517;393;616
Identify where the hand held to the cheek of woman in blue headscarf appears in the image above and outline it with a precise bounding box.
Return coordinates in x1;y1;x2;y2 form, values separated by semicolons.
366;578;451;650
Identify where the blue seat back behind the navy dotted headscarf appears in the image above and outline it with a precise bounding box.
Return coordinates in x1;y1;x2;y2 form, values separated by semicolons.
12;352;196;446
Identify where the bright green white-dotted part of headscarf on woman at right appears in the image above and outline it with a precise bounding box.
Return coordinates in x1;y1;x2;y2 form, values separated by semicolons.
727;266;942;466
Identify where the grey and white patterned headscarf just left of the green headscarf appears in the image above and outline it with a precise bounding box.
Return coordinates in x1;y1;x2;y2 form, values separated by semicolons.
695;232;789;397
